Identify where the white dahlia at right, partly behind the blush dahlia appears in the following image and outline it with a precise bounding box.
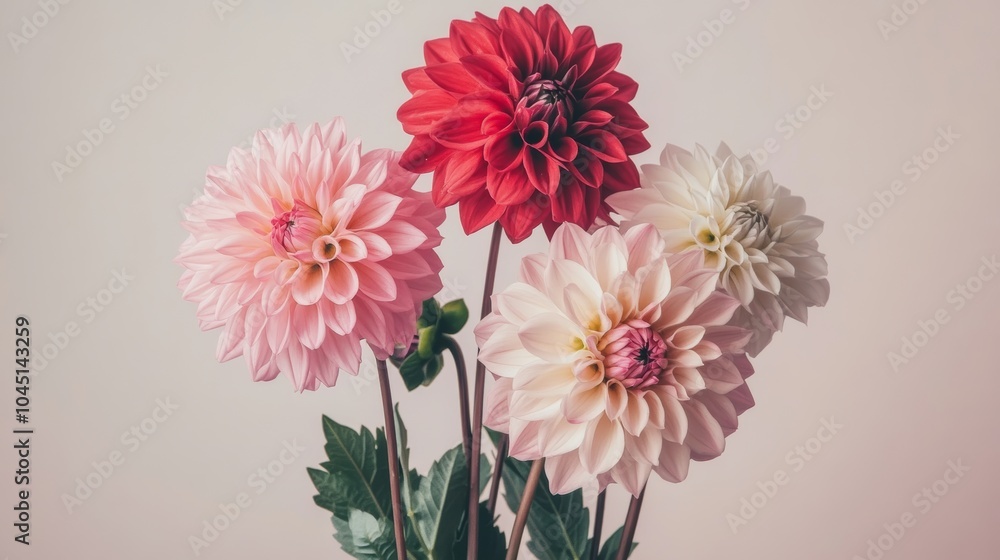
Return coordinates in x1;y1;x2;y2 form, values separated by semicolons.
608;144;830;356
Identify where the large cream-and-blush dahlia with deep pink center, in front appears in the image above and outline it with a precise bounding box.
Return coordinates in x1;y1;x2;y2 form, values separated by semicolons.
476;224;753;495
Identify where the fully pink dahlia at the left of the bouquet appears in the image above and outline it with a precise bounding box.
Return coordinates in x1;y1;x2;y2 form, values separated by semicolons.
176;119;444;391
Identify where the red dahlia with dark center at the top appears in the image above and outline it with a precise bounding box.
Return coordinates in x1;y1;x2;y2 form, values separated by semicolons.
398;5;649;242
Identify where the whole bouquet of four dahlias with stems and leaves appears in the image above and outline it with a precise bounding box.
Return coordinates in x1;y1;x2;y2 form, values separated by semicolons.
177;6;829;560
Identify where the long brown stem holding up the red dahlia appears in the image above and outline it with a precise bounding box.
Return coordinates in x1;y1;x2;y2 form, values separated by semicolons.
467;222;503;558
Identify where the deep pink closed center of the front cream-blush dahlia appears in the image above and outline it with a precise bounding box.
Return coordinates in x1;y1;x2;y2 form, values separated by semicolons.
602;321;667;389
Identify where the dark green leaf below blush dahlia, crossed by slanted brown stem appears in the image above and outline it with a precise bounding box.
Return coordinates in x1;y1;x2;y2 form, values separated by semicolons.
503;458;590;560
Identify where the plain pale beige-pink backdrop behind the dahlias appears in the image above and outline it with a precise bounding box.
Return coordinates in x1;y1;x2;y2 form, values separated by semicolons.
0;0;1000;560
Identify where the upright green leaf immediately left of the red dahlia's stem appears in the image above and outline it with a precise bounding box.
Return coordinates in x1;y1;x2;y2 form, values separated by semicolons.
414;445;469;560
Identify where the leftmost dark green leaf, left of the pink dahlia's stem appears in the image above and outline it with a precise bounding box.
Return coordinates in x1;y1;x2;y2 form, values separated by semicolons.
309;416;392;519
